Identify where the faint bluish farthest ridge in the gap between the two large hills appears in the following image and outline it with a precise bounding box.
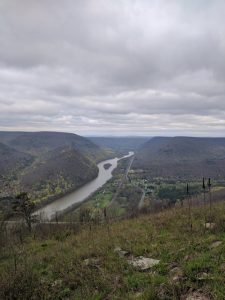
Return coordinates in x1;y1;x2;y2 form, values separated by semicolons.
88;136;150;154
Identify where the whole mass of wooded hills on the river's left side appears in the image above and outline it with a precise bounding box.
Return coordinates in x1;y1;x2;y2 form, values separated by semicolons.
0;132;112;201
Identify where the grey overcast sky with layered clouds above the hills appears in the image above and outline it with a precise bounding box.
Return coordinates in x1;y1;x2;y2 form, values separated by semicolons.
0;0;225;136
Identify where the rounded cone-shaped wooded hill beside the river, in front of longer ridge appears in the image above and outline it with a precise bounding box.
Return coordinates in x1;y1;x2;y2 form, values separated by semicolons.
20;147;98;200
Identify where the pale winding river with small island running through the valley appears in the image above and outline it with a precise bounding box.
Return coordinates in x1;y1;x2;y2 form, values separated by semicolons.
35;151;134;220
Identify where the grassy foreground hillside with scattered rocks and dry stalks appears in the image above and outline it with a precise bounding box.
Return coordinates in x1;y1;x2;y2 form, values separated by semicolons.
0;202;225;300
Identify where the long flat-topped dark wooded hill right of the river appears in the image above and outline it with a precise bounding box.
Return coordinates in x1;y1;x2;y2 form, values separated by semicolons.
133;137;225;178
